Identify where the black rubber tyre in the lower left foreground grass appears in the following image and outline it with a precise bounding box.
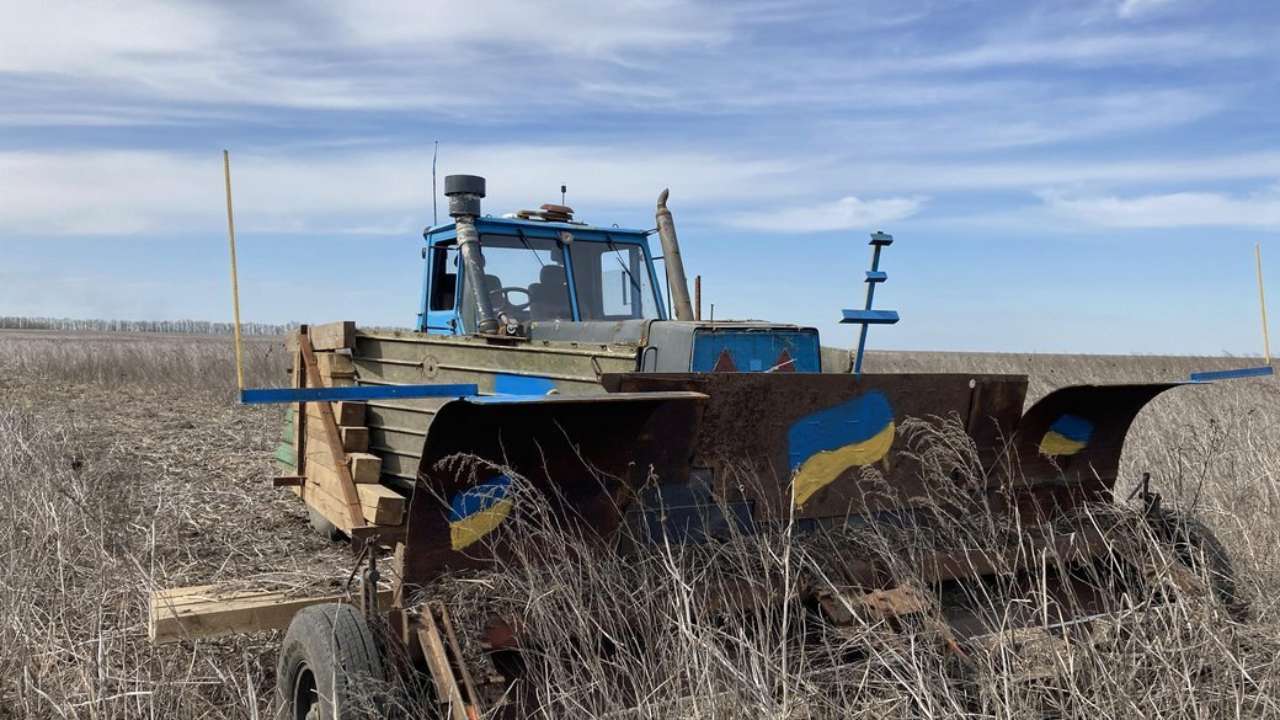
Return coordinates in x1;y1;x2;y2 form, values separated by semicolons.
275;605;387;720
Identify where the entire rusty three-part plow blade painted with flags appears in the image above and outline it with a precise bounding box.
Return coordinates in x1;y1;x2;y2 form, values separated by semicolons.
406;373;1175;587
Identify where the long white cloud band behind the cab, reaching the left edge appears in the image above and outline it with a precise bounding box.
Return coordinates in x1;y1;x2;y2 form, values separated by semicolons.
0;145;788;236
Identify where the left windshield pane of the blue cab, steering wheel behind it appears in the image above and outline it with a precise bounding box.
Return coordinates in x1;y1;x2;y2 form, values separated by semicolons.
462;234;573;328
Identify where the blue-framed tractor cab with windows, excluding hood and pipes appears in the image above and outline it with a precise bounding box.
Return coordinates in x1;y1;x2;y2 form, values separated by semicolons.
417;217;667;334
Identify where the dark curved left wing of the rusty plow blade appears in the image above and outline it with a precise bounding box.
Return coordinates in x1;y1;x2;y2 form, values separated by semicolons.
403;392;704;585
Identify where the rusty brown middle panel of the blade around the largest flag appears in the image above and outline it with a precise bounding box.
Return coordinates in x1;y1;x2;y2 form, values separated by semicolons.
600;373;1027;521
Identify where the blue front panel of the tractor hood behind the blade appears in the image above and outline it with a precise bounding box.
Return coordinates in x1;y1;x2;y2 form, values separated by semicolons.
689;328;822;373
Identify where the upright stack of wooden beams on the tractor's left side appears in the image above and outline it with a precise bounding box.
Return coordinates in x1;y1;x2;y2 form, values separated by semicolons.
275;322;407;536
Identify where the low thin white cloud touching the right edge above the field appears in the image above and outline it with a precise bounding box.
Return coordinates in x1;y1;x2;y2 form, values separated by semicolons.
1041;186;1280;228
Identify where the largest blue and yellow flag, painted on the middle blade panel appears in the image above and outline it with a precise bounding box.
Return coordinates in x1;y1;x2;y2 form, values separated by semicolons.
787;391;895;507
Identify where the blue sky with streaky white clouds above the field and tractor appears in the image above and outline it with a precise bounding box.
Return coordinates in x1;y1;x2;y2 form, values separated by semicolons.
0;0;1280;354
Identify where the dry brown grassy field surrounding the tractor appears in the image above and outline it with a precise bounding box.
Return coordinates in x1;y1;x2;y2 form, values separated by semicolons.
0;332;1280;720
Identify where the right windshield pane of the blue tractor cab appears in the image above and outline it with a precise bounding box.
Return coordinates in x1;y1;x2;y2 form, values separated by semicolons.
570;241;660;320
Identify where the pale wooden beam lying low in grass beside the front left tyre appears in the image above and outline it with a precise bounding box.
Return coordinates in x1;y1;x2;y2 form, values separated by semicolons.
147;585;393;643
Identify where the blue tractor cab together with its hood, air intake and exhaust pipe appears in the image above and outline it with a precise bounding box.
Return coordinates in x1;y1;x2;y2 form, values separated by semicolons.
417;176;822;373
